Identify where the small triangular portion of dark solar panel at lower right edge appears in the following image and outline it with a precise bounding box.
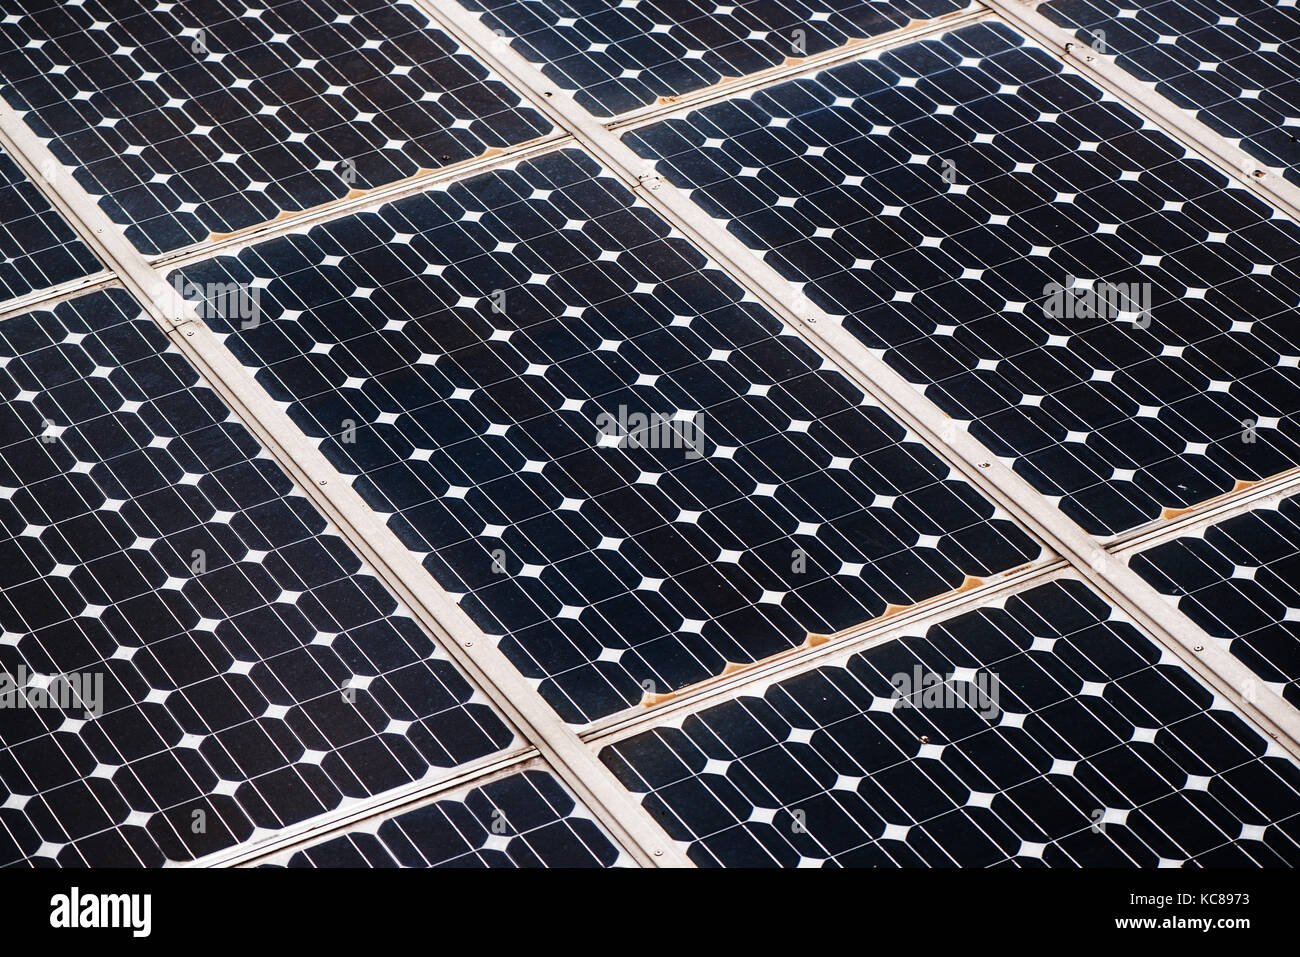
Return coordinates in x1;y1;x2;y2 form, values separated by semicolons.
1130;498;1300;707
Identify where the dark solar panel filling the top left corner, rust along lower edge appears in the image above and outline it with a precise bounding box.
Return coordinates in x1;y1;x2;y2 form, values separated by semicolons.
0;0;551;254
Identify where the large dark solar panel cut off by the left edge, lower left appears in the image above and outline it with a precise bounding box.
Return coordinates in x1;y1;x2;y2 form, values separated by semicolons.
0;290;512;866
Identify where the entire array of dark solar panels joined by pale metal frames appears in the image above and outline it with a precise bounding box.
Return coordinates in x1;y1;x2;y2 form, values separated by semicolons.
0;0;1300;869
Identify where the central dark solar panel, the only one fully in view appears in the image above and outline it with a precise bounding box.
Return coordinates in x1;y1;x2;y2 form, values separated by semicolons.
178;151;1039;720
